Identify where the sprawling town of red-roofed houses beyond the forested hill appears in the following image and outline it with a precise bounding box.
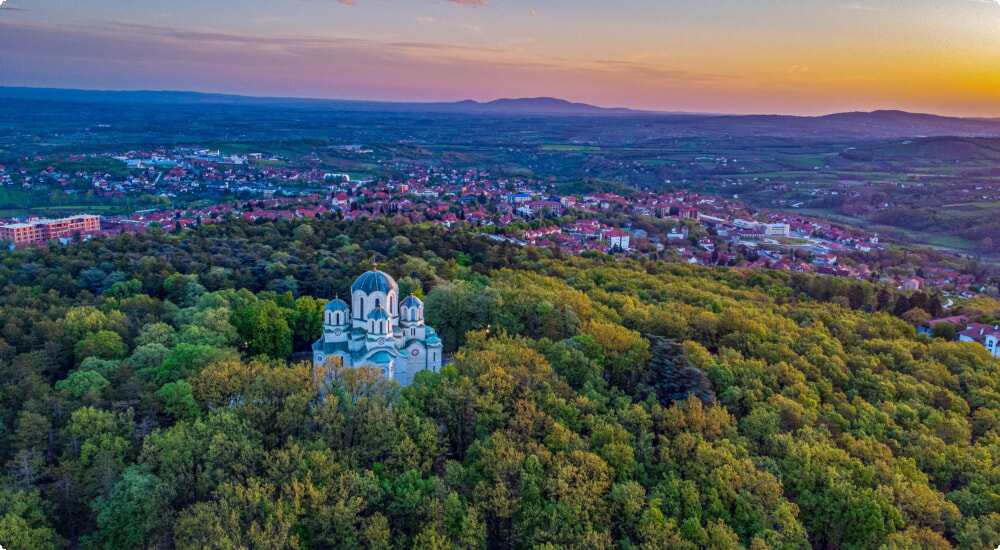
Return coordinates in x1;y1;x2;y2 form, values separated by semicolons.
0;149;984;297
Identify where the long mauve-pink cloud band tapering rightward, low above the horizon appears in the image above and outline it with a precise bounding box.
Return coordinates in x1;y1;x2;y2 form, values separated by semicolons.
0;18;752;110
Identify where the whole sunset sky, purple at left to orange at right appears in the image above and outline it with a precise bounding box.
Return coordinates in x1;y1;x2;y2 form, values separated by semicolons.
0;0;1000;117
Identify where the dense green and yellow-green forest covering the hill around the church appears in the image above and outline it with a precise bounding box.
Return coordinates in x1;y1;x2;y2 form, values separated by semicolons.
0;219;1000;550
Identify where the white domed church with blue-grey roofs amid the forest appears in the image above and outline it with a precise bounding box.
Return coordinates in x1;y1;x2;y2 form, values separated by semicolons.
313;269;442;386
